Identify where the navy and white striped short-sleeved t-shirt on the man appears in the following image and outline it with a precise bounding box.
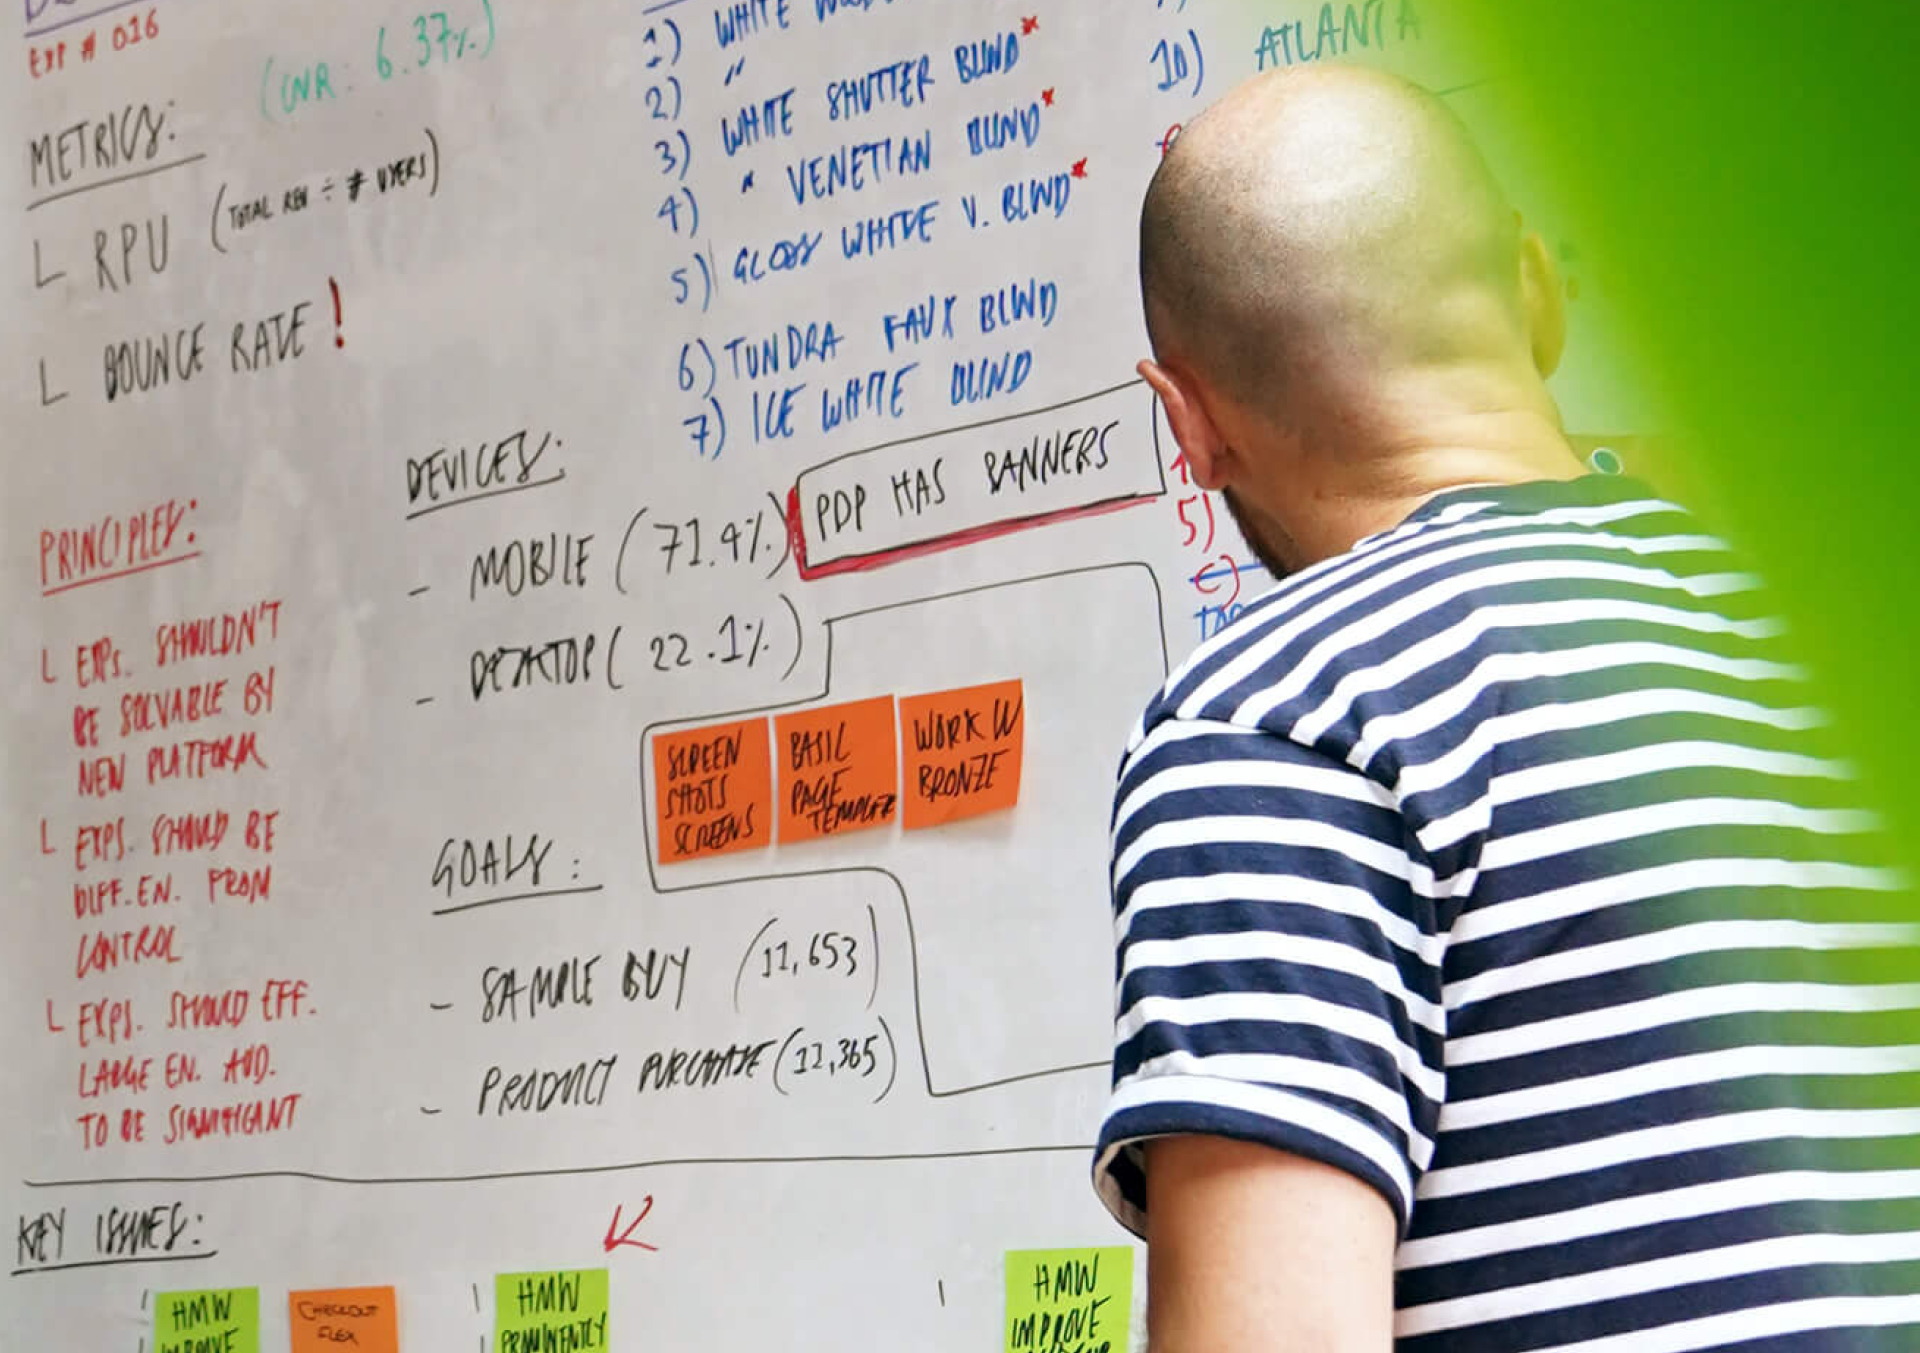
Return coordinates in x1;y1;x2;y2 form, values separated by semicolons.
1094;476;1920;1353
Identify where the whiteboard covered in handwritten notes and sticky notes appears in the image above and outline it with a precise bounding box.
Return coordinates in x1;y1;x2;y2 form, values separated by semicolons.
0;0;1651;1353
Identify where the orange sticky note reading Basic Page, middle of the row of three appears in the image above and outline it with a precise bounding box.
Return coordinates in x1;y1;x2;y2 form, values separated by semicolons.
774;695;900;844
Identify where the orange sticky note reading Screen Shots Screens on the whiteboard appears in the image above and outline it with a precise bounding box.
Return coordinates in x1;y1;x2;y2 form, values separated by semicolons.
653;718;774;864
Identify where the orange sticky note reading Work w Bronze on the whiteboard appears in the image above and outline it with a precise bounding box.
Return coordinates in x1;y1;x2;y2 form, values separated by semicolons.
900;679;1027;831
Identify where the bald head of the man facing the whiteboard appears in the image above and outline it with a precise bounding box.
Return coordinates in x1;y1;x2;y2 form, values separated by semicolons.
1140;65;1528;426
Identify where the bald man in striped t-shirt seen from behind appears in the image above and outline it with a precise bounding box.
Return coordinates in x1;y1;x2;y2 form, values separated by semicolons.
1096;67;1920;1353
